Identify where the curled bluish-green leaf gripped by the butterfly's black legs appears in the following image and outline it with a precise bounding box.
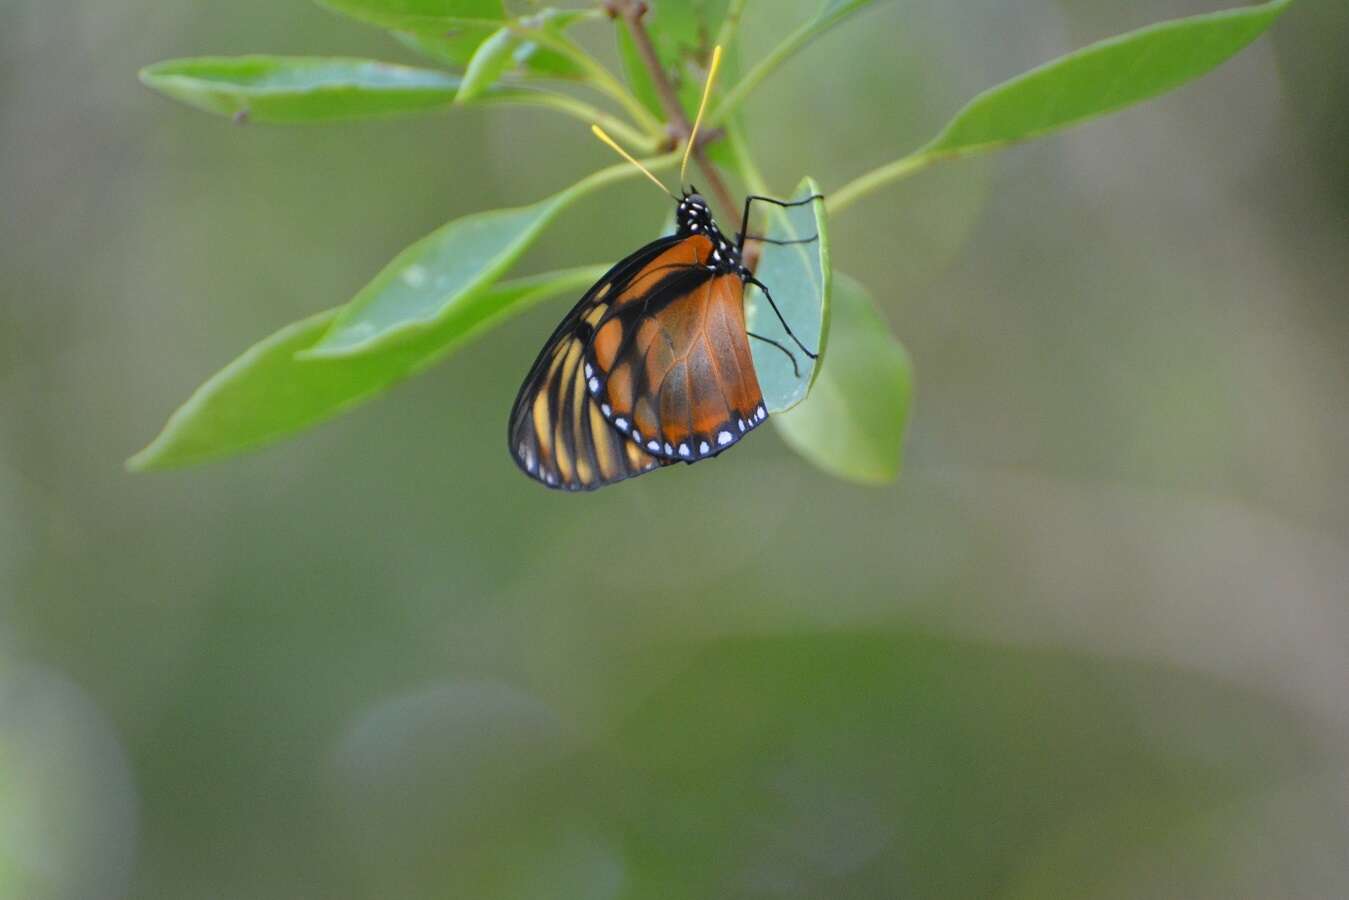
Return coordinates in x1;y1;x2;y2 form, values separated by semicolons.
745;178;832;413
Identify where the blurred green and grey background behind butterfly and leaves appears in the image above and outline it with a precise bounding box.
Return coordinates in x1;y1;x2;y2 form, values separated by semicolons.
0;0;1349;900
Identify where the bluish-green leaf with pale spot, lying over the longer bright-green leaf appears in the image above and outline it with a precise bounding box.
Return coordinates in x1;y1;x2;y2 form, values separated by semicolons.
306;154;676;358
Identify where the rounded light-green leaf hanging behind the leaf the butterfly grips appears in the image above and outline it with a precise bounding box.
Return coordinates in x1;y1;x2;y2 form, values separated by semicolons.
773;274;913;484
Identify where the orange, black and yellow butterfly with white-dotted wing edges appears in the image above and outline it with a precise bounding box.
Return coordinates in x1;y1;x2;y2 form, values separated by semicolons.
509;193;768;491
